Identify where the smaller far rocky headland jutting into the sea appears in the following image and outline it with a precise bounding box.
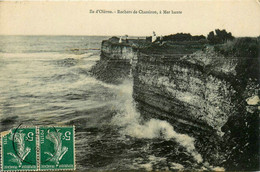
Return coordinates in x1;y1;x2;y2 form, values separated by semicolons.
91;40;137;84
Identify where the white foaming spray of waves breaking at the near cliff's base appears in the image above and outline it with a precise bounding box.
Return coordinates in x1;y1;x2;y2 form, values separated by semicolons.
109;81;203;163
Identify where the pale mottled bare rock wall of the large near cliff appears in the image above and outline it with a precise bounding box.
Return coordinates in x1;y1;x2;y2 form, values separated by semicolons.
134;46;236;134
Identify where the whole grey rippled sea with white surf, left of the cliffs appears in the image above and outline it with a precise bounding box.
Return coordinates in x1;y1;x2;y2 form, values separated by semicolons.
0;36;223;170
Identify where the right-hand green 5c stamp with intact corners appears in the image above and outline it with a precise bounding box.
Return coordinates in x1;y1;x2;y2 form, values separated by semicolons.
39;126;75;170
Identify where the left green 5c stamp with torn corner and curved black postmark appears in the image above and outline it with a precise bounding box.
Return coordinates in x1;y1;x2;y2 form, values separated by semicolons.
1;127;37;171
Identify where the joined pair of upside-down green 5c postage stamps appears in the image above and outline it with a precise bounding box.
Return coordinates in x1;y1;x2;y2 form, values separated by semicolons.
1;126;76;171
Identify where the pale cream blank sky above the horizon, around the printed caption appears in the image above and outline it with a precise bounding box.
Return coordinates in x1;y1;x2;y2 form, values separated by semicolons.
0;0;260;36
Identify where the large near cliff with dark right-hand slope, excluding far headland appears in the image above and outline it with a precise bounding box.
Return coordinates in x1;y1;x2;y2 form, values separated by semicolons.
133;42;259;170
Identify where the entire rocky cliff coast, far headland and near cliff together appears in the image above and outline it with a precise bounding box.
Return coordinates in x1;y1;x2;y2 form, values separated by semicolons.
92;38;260;170
